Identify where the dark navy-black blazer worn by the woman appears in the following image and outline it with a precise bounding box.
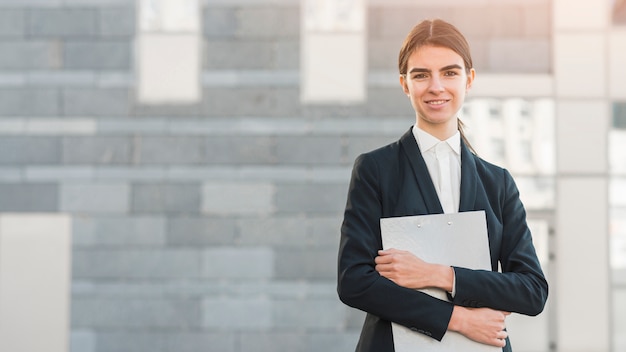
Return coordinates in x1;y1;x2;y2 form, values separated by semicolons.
337;129;548;352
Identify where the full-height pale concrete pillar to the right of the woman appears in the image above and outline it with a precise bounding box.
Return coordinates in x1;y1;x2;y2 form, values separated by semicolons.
551;0;611;352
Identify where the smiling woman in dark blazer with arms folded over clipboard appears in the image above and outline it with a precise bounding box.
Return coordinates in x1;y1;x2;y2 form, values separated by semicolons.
338;20;548;352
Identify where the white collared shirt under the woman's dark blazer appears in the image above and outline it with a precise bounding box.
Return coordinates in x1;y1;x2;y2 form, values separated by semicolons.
413;125;461;214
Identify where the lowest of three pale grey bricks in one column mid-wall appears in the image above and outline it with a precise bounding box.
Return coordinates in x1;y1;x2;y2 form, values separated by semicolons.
202;297;272;329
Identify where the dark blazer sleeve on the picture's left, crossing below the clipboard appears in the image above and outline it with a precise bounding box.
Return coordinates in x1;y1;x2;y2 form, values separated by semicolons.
337;154;453;340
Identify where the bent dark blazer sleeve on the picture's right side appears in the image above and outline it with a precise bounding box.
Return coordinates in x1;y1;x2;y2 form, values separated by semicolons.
453;170;548;315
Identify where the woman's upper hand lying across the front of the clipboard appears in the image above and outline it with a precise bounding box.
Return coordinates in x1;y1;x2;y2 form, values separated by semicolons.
374;248;454;292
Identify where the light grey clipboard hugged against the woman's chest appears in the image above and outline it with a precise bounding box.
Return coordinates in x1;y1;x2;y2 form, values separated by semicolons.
380;210;494;352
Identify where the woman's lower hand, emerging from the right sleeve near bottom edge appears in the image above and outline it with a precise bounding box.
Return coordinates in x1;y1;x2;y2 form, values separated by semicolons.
448;306;511;347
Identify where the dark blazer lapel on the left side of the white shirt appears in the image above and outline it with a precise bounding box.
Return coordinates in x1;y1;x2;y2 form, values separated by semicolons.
400;127;443;214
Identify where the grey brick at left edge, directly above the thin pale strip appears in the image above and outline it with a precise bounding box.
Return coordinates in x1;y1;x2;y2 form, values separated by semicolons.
0;87;60;116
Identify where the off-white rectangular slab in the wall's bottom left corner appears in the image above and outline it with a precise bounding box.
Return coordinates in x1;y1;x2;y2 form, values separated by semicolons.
0;214;71;352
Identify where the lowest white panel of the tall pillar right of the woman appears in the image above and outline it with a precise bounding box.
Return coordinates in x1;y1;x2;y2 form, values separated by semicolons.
552;177;610;352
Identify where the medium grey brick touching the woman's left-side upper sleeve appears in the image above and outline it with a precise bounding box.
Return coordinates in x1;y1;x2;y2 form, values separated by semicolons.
276;180;350;213
